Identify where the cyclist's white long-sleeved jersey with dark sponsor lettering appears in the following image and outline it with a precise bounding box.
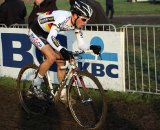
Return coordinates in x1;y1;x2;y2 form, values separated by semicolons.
31;10;89;51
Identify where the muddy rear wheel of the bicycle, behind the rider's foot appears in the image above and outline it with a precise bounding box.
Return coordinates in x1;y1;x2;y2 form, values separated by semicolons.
17;64;48;115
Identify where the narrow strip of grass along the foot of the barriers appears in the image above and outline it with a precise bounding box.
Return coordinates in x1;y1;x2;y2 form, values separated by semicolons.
0;77;160;104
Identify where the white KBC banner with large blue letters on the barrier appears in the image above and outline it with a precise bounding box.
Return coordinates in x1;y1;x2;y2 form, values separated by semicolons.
0;28;125;91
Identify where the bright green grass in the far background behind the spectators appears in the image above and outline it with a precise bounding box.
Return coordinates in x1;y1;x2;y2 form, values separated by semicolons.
25;0;160;15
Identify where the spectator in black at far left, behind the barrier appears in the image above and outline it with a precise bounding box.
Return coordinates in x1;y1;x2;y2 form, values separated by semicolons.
0;0;27;27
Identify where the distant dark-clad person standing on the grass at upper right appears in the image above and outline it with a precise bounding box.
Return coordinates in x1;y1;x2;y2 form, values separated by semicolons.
106;0;114;20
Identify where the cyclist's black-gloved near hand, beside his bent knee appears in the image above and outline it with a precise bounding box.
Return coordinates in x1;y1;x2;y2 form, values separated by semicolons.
60;48;73;60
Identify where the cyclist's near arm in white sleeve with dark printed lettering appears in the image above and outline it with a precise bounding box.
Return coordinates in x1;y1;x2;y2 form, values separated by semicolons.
47;25;63;52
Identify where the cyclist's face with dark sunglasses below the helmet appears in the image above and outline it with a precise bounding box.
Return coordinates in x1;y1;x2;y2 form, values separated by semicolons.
73;16;89;29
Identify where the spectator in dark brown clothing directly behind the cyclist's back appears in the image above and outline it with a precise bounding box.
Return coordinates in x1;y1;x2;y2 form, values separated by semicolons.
28;0;58;26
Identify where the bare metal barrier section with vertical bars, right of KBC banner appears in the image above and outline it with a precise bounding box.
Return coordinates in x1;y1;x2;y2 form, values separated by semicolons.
121;25;160;94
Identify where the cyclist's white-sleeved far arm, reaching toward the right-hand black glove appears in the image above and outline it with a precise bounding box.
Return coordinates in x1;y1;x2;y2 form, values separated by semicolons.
75;29;89;50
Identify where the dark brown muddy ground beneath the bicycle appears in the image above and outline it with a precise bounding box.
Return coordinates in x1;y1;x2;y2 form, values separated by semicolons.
0;86;160;130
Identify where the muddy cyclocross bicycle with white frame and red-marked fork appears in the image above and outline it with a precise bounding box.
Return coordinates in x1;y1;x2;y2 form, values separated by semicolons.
17;51;107;130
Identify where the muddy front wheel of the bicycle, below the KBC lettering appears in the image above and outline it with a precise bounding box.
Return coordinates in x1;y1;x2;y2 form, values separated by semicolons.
67;71;107;130
